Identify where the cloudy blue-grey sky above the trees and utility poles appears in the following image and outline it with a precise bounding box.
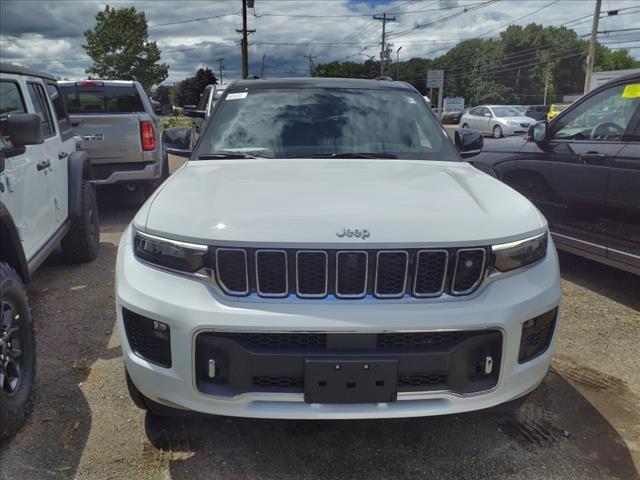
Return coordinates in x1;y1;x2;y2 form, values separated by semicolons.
0;0;640;83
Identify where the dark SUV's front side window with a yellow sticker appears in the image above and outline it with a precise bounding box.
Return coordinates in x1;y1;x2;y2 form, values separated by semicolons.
553;85;640;142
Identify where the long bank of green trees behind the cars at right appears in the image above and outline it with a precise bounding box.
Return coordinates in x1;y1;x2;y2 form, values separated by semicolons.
316;23;640;105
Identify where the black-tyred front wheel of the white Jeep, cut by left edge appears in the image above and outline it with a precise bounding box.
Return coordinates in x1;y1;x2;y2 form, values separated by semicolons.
0;262;36;440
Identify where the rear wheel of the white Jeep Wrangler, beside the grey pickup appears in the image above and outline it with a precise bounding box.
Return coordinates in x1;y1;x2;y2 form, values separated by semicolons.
61;180;100;262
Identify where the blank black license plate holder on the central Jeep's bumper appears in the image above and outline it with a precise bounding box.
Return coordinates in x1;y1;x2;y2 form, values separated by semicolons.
304;358;398;403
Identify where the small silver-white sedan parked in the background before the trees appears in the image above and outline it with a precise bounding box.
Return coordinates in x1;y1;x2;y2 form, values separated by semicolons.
460;105;536;138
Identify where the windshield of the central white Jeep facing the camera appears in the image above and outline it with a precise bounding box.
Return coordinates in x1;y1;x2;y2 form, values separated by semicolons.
195;88;459;161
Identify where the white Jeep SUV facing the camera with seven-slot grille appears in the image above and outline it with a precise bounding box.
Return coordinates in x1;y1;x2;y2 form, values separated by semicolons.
116;79;561;419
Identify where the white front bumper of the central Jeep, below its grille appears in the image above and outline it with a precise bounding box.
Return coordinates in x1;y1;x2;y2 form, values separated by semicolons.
116;230;561;419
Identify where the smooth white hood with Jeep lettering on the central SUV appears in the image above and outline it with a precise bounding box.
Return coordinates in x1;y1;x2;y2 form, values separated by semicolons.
140;159;546;248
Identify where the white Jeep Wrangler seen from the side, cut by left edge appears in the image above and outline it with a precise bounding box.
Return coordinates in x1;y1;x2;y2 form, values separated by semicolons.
0;64;100;439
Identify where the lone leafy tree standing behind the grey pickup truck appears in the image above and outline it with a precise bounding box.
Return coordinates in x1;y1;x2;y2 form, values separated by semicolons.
82;5;169;91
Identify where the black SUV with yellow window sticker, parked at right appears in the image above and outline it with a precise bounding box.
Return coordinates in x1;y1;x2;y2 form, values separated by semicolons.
471;73;640;275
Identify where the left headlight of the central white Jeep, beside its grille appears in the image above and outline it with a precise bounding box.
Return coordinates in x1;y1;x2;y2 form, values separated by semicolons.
133;231;209;273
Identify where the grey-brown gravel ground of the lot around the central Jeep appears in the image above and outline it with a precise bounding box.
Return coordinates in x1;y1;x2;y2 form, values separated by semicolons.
0;155;640;480
